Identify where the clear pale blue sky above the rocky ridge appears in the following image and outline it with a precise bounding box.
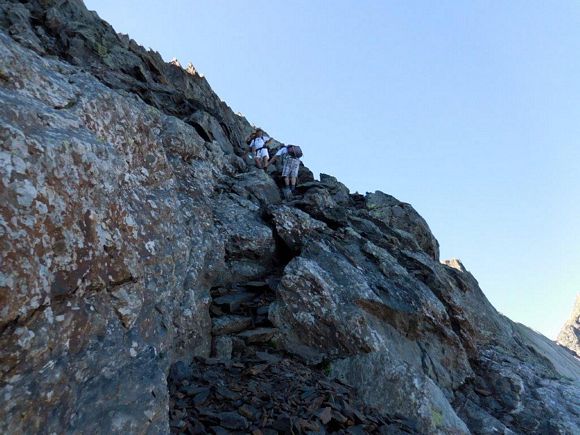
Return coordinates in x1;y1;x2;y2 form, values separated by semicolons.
85;0;580;338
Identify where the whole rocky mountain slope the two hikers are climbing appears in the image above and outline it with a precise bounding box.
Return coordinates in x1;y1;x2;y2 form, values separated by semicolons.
0;0;580;433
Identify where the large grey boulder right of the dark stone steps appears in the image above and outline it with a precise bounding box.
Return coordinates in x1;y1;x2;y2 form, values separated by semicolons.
270;230;473;433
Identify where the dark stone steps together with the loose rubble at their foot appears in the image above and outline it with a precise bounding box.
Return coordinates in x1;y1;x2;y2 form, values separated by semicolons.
168;276;416;435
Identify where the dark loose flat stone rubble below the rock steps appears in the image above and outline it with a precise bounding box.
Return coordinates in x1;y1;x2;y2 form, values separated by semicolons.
169;351;416;435
